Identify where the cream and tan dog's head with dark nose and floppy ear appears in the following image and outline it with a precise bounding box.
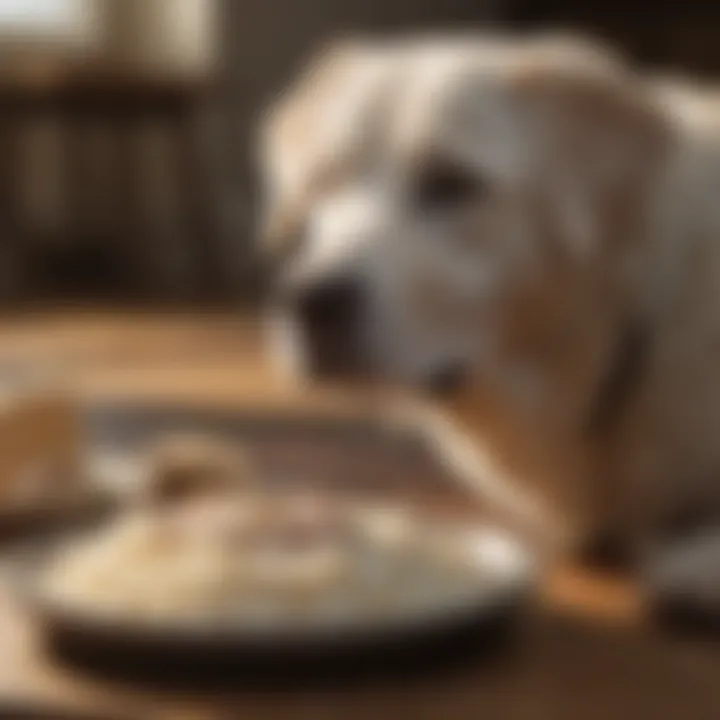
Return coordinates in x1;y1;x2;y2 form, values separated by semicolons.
261;39;665;402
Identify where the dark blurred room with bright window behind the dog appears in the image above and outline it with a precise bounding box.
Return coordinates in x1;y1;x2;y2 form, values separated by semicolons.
0;0;720;304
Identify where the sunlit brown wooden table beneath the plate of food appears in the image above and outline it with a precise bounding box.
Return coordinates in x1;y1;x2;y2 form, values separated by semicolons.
0;313;720;720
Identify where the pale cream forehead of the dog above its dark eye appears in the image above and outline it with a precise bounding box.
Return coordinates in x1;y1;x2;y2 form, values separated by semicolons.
286;44;524;184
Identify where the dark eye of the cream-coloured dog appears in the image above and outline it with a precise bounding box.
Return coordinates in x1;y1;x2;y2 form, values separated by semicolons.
414;162;485;212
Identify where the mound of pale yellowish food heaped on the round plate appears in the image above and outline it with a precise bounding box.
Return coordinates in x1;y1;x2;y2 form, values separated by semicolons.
42;493;516;631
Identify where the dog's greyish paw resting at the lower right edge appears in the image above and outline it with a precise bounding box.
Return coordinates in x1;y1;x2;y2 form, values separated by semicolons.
643;527;720;631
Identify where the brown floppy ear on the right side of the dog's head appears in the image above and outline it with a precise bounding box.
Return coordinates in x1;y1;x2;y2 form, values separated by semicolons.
513;46;672;253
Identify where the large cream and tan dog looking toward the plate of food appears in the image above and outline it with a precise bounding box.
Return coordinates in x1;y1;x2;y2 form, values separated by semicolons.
261;33;720;596
